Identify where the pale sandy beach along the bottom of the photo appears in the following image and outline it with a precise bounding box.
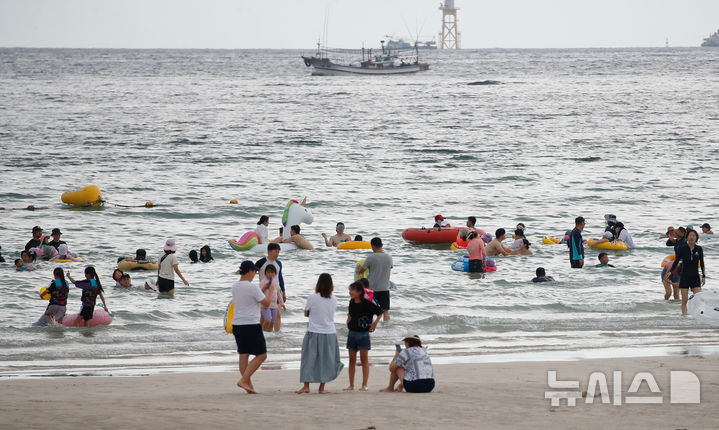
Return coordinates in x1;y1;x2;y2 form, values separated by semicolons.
0;355;719;429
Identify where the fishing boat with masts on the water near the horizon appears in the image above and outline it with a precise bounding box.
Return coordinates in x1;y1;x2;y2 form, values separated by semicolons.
302;40;429;76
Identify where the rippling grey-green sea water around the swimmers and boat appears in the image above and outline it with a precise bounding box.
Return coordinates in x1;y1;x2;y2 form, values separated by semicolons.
0;48;719;376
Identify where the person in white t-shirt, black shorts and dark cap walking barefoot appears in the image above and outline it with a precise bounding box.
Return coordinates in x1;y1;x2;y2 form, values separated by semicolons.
232;260;271;394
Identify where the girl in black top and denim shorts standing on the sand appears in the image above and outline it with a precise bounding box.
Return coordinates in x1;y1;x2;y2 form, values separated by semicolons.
345;278;383;391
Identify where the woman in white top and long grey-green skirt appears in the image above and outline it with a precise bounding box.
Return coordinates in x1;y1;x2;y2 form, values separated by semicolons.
296;273;344;394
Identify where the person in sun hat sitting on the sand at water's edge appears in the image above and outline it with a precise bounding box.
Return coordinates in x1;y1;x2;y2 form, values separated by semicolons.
380;333;434;393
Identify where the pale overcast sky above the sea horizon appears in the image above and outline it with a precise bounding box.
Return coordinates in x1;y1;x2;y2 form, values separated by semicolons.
0;0;719;49
